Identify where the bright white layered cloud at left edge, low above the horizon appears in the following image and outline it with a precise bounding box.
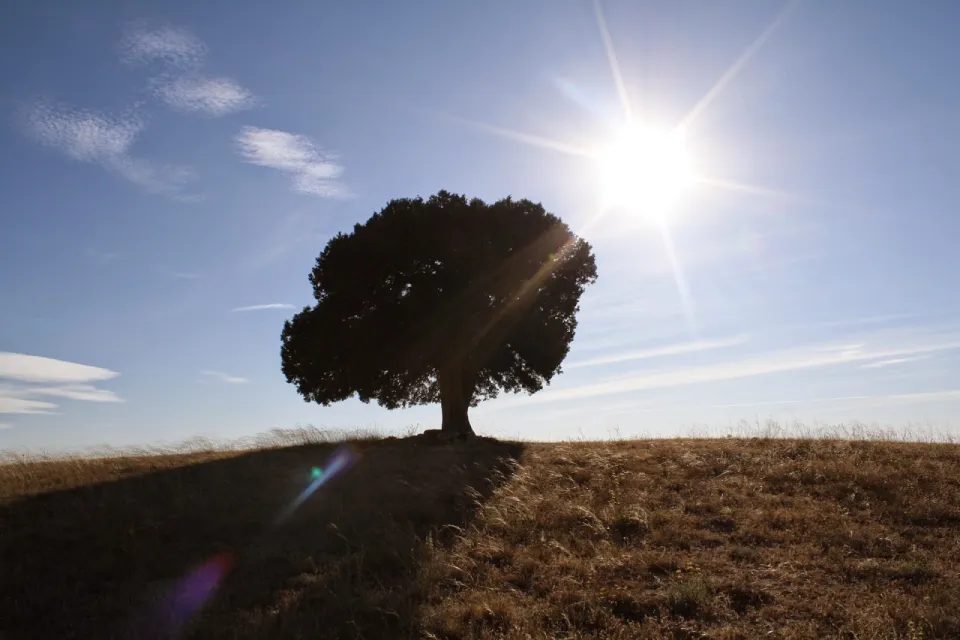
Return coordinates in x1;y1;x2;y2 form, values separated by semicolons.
0;352;123;414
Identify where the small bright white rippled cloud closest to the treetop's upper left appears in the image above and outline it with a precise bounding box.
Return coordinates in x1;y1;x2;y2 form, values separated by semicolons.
235;127;348;198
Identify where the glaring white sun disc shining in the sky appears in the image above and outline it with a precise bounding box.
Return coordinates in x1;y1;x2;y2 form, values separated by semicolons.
597;126;693;219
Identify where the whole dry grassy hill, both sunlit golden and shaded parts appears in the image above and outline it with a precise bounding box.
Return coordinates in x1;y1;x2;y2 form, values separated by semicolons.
0;437;960;640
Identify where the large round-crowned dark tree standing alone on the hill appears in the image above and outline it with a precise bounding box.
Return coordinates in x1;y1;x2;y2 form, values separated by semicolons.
281;191;597;434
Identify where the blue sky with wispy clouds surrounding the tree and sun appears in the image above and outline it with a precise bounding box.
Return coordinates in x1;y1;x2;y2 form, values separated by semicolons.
0;0;960;450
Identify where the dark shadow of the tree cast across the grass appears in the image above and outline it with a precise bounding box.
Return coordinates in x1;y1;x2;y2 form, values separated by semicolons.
0;438;522;640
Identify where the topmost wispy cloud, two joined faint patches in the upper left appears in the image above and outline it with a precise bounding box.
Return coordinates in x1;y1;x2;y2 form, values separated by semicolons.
120;23;256;117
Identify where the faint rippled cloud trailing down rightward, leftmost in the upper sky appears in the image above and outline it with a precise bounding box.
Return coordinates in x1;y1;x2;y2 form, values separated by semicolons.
25;102;193;197
